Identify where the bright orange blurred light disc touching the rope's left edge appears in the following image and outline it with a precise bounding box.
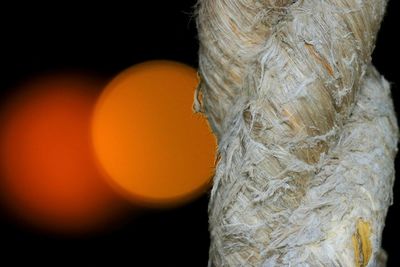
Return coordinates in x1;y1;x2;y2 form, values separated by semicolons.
92;61;216;206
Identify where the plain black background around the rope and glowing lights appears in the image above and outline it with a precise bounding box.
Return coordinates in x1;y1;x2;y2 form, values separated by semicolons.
0;0;400;267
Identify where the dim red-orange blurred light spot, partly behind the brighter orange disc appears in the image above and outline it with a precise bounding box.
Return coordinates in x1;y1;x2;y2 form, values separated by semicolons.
0;74;125;233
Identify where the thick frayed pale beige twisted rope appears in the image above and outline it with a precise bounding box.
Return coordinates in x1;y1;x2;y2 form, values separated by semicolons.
195;0;398;266
